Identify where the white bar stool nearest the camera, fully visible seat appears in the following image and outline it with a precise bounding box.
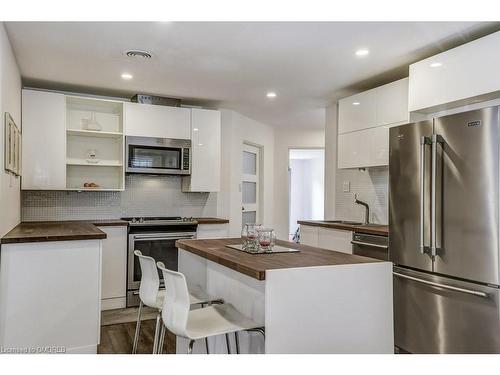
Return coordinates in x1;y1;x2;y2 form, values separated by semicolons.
157;262;265;354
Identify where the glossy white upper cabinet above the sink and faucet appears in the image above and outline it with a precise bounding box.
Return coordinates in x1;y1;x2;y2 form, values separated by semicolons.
338;78;409;169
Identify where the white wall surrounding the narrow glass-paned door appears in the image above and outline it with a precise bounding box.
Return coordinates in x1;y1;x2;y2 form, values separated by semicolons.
217;109;275;237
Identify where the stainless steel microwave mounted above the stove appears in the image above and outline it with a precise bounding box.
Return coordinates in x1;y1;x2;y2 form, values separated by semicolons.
125;137;191;175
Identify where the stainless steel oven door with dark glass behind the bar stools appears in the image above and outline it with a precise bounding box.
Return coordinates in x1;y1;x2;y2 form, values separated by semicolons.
127;232;196;291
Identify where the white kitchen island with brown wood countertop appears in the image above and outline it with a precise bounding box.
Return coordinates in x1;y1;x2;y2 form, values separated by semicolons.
177;239;394;353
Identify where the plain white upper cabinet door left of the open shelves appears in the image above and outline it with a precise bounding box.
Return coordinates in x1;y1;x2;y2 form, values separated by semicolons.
21;90;66;190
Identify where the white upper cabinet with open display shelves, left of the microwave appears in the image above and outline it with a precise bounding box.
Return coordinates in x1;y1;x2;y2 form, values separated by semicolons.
21;90;124;190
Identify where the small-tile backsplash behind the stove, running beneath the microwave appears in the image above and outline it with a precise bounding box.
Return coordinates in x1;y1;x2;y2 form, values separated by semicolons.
21;175;217;221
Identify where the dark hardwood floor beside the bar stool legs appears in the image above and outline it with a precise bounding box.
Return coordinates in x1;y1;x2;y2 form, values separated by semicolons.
97;320;175;354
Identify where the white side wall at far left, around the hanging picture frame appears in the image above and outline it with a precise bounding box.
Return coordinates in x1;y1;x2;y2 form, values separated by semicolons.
0;23;21;237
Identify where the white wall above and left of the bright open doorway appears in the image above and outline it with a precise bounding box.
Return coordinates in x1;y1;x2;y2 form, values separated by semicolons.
274;129;328;240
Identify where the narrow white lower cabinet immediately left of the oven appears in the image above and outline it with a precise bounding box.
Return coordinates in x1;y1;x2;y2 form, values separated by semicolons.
99;226;127;310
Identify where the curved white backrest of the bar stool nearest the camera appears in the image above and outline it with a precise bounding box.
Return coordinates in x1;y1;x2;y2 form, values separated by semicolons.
157;262;190;337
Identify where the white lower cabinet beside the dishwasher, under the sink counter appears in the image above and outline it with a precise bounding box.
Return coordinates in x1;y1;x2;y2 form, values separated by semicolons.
300;225;352;254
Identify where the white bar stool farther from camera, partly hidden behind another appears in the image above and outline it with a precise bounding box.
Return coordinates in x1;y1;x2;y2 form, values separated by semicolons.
132;250;223;354
